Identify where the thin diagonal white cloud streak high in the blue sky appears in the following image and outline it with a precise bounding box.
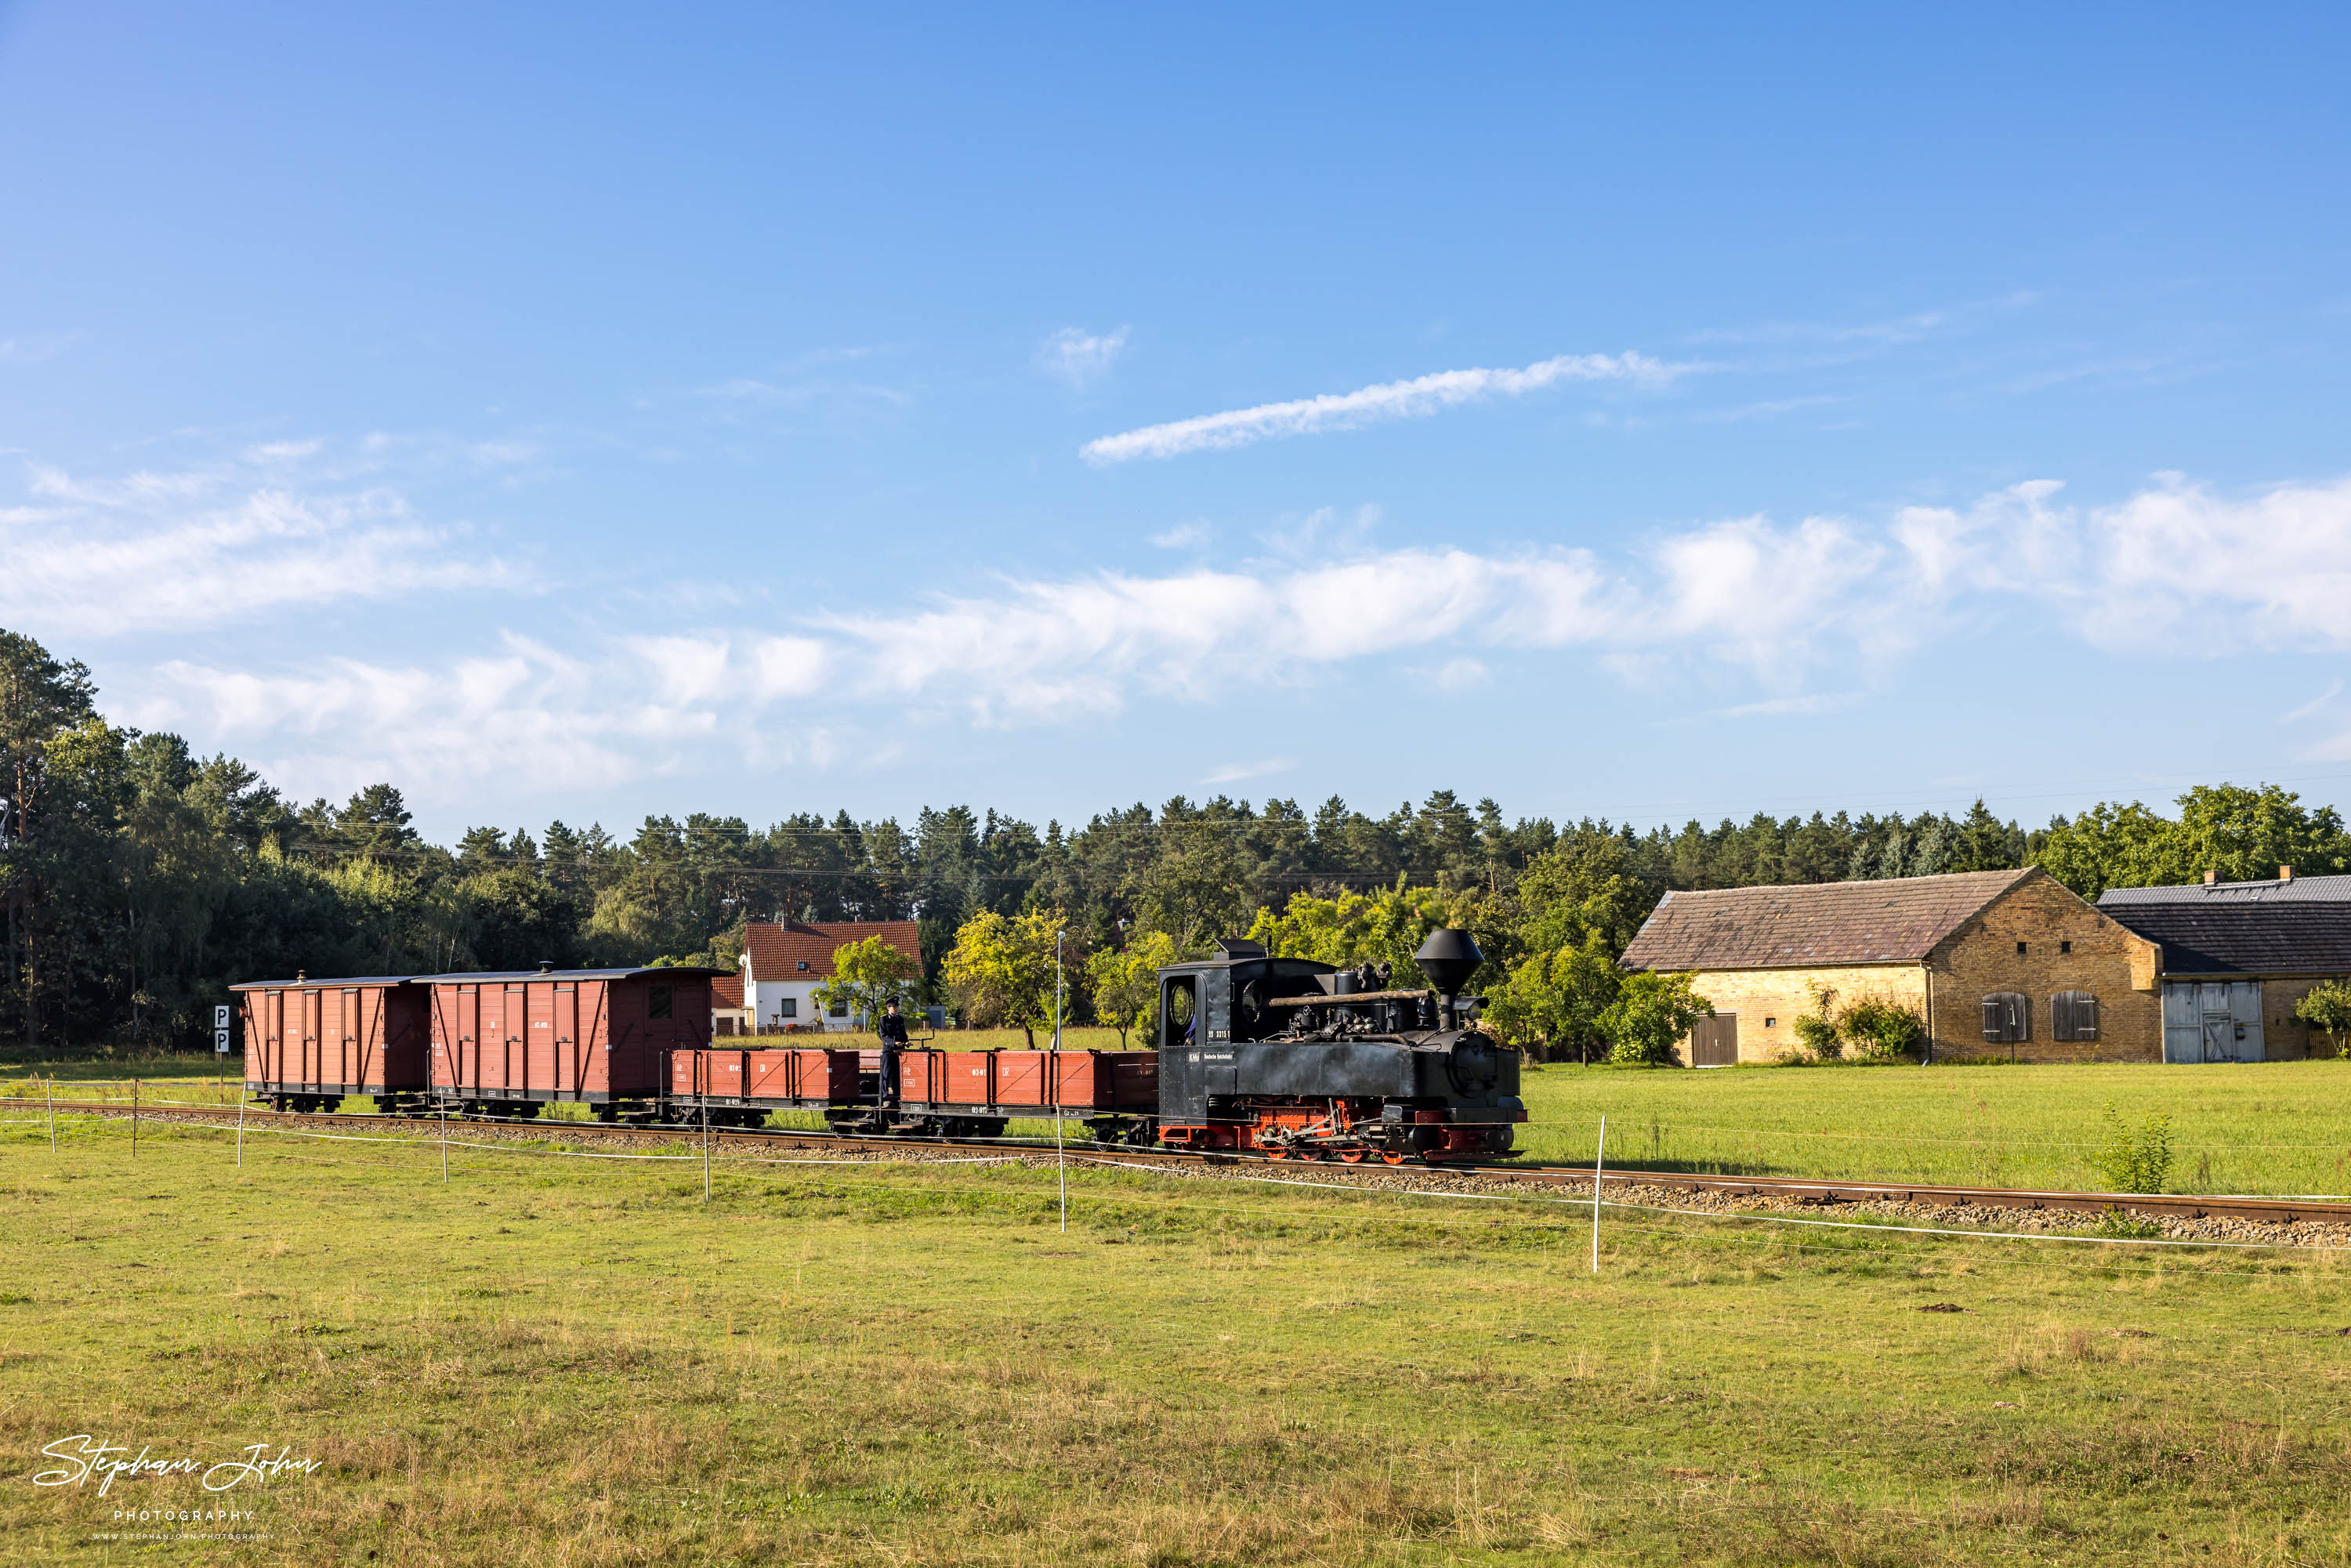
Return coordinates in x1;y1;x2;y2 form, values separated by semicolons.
1081;353;1688;463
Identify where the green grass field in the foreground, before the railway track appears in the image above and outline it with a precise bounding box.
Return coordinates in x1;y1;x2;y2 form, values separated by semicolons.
0;1119;2351;1568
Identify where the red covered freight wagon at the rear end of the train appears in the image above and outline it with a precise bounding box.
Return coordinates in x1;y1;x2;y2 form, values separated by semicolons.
228;976;428;1110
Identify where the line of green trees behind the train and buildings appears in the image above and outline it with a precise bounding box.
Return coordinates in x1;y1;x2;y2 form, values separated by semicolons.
0;630;2351;1053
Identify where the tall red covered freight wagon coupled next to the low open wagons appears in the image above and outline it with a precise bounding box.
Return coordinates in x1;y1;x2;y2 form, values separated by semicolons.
426;969;717;1121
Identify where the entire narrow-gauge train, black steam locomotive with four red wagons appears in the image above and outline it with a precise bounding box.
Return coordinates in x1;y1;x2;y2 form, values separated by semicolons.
235;929;1526;1164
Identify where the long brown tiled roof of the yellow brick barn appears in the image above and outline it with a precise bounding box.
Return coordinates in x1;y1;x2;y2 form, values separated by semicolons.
1622;865;2048;969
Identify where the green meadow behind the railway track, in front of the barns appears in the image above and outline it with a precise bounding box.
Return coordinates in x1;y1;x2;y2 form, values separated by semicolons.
13;1053;2351;1197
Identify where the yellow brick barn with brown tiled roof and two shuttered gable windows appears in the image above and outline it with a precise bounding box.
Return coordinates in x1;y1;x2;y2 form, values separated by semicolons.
1622;867;2163;1067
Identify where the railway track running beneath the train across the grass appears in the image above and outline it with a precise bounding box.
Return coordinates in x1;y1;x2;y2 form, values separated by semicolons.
23;1100;2351;1225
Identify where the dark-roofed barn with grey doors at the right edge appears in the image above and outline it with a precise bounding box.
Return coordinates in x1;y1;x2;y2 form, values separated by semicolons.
2097;865;2351;1063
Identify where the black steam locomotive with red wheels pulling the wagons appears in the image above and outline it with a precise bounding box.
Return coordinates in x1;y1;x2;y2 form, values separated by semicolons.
1157;929;1526;1166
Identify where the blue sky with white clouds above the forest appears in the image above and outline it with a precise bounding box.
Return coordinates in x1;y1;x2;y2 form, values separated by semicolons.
0;0;2351;839
